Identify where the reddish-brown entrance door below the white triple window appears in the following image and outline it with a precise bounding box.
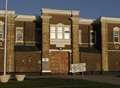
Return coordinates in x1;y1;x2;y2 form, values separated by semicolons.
50;52;69;74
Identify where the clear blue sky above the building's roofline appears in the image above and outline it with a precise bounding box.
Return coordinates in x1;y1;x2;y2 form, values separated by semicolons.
0;0;120;19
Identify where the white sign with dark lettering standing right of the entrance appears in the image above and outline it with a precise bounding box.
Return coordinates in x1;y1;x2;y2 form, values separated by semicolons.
71;63;86;73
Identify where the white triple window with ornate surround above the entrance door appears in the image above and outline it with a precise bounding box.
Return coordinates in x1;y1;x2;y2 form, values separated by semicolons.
50;23;71;47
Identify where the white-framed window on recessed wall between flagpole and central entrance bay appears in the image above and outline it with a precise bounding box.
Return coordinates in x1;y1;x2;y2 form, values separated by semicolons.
16;27;24;43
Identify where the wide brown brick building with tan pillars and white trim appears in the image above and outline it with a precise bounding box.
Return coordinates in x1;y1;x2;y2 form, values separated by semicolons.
0;8;120;74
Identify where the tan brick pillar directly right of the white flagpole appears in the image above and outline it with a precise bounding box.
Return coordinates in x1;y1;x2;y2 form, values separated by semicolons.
7;15;15;72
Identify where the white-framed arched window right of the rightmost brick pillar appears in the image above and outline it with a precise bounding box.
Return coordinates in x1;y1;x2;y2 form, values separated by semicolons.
113;27;120;43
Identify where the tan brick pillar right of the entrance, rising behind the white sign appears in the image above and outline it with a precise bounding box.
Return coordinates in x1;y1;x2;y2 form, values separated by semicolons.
71;17;80;64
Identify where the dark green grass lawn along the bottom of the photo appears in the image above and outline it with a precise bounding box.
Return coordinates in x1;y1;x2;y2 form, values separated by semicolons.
0;78;120;88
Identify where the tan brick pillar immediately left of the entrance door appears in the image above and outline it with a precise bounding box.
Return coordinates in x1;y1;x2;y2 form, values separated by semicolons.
41;16;51;71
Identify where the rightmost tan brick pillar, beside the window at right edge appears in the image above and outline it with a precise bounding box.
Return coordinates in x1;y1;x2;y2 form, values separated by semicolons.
101;21;108;71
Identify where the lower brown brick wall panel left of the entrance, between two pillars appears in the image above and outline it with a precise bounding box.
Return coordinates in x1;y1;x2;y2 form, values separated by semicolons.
15;52;41;72
